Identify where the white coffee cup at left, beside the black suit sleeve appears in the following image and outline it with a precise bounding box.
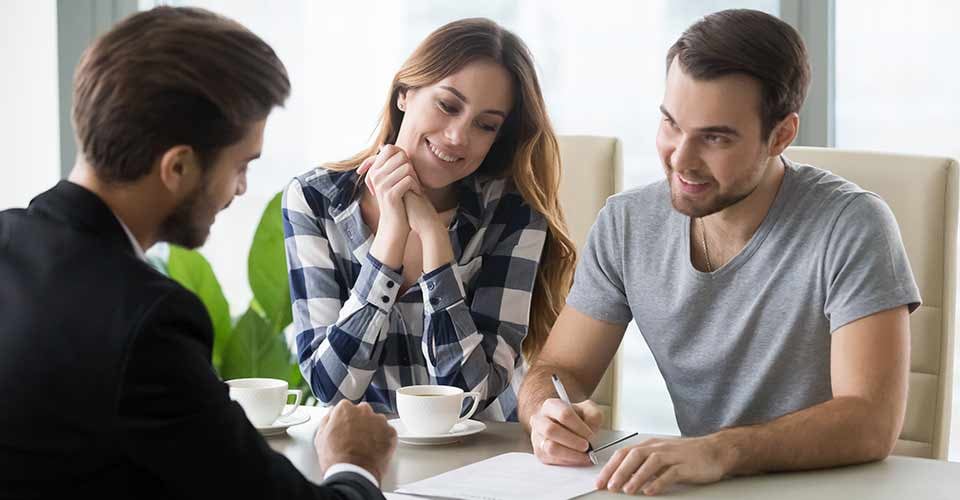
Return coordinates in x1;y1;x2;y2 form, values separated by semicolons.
227;378;303;427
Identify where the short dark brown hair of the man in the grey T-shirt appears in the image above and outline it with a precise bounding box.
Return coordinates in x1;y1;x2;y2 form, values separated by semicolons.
667;9;810;140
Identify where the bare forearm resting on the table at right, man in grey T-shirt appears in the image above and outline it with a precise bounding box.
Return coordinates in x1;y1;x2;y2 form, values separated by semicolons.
707;397;903;475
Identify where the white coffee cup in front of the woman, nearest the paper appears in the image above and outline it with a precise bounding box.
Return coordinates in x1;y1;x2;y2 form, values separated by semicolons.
397;385;480;436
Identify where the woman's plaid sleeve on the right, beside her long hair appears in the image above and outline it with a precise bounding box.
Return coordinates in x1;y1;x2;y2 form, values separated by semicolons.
420;196;547;411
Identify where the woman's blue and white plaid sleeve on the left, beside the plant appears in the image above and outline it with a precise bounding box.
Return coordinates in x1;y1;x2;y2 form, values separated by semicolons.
282;179;402;405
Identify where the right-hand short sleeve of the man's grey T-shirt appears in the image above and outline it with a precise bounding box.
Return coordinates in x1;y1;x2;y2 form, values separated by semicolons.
823;193;920;332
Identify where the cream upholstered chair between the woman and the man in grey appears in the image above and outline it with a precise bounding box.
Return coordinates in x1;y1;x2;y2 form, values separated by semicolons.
559;136;623;427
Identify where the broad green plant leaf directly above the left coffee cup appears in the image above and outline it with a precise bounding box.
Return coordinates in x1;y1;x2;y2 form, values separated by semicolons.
220;309;291;382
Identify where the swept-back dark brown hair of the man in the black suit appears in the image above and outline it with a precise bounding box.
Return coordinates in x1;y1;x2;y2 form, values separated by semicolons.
73;7;290;182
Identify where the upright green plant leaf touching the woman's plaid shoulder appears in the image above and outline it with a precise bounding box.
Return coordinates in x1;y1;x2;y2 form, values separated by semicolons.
247;193;293;331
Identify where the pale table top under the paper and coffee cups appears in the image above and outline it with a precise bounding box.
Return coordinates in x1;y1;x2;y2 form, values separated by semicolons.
267;407;960;500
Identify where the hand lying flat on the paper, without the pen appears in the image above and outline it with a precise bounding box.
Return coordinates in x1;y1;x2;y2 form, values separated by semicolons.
597;435;732;496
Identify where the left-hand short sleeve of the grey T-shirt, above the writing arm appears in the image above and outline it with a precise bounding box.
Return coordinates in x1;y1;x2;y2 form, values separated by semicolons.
567;200;633;324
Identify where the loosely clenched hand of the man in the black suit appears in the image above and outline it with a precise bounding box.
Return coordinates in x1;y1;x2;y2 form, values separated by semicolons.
314;400;397;481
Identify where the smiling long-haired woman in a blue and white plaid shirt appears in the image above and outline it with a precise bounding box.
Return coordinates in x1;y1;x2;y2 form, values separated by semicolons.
283;19;576;420
